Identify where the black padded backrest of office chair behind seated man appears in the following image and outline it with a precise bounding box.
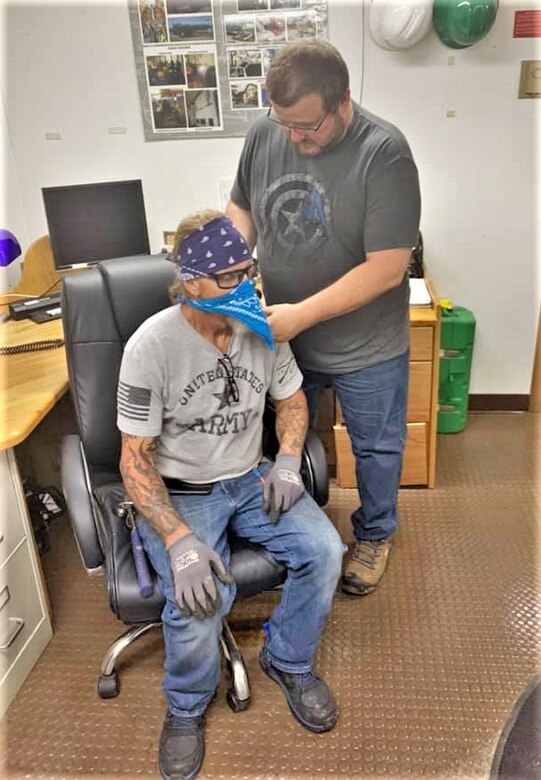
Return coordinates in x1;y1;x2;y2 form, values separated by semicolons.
62;255;174;473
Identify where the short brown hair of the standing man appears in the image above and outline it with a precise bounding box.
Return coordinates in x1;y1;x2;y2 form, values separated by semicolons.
266;39;349;113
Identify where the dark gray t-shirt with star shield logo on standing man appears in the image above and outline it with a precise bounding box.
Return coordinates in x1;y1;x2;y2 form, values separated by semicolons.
231;103;420;374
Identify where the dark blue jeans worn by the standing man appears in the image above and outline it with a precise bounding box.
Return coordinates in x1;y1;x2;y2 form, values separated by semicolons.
303;351;409;541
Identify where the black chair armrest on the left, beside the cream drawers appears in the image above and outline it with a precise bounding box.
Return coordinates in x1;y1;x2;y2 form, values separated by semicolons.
60;433;104;572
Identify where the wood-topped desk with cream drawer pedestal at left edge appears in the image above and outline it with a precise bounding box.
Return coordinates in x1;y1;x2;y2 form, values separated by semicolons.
0;320;68;717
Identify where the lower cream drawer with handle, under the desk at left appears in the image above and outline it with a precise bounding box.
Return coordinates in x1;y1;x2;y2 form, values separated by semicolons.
0;540;45;678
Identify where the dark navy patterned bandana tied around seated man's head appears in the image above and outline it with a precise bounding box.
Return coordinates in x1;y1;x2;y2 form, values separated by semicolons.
175;217;251;280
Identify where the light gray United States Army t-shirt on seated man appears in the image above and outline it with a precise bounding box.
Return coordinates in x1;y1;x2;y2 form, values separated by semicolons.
117;306;302;482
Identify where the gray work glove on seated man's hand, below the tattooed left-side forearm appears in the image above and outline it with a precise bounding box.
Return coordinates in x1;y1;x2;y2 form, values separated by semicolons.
166;533;234;620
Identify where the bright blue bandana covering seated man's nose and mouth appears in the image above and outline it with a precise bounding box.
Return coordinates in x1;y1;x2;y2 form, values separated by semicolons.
182;279;274;349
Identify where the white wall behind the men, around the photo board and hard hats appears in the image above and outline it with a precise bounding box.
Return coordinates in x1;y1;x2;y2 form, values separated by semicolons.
0;0;541;393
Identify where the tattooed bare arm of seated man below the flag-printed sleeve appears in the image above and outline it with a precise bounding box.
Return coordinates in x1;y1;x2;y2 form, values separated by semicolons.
120;433;191;546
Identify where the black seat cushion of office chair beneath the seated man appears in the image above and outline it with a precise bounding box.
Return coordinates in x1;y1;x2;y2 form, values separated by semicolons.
94;482;286;625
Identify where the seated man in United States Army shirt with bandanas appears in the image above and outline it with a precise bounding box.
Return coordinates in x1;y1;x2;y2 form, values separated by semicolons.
118;211;344;780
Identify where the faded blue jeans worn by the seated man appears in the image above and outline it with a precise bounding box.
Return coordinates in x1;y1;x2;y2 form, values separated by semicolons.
137;460;345;717
